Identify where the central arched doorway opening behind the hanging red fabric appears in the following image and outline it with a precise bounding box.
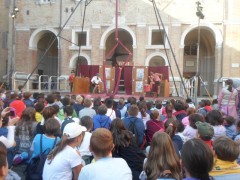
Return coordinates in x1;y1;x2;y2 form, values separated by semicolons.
105;29;133;93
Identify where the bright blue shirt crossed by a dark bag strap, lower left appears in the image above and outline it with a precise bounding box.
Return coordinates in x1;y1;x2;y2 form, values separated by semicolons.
31;134;60;159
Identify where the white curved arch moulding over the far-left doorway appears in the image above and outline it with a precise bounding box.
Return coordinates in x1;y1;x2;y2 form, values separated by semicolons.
29;28;59;50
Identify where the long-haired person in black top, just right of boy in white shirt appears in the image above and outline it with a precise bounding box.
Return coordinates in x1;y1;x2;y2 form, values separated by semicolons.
110;118;145;180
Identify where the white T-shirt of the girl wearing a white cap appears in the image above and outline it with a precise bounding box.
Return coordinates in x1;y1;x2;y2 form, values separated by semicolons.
42;145;81;180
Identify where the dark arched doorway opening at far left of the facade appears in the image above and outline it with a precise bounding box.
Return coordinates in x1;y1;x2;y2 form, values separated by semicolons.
37;31;58;76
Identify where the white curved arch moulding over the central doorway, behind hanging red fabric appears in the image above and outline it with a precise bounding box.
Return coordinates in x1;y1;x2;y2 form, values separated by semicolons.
100;25;137;49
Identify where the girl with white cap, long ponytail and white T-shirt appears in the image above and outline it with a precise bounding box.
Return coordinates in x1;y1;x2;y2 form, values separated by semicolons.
42;123;87;180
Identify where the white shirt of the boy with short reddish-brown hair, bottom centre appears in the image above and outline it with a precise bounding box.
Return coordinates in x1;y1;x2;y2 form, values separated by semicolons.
78;157;132;180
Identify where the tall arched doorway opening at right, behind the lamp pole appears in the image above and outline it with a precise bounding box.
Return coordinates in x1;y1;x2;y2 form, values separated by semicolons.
183;26;216;96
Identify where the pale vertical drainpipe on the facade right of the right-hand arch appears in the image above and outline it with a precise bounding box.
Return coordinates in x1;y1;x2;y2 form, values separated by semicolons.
217;0;226;94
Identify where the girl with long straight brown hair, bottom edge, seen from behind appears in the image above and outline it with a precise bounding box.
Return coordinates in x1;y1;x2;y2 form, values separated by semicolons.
144;131;181;180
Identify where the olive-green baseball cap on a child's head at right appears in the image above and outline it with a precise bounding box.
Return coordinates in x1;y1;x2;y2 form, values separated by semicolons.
196;121;214;139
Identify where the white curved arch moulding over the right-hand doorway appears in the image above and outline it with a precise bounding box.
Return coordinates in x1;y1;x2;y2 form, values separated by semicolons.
180;23;223;48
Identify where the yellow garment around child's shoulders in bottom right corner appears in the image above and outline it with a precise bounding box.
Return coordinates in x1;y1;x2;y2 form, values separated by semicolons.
209;159;240;176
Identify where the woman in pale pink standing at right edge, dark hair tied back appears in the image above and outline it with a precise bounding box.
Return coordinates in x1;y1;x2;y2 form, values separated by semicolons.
218;79;239;119
